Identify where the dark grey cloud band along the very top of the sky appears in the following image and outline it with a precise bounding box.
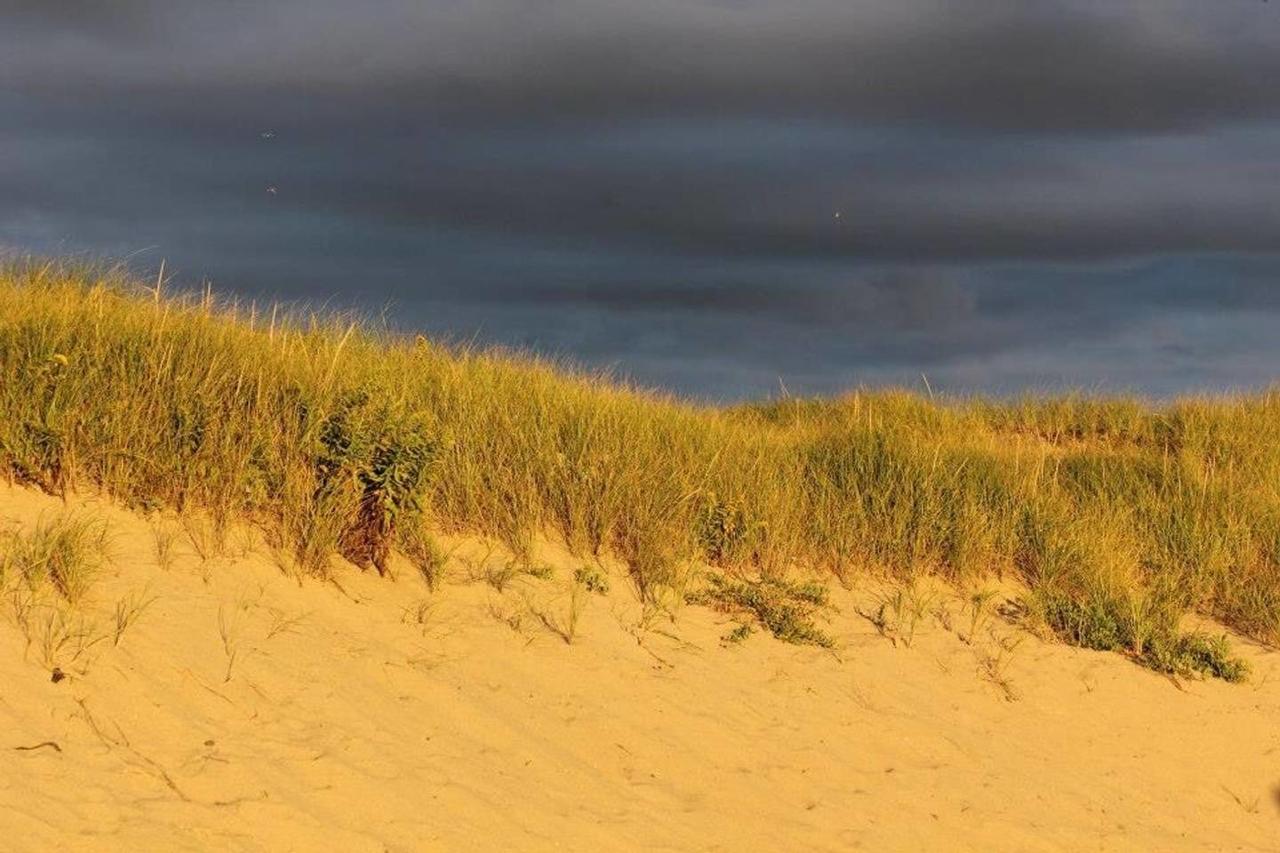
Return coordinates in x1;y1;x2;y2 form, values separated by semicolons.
0;0;1280;131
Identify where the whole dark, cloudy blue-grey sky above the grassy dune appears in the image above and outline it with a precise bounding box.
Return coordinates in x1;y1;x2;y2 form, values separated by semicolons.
0;0;1280;401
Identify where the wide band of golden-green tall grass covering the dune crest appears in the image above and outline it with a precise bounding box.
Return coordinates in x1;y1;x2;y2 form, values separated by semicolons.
0;263;1280;656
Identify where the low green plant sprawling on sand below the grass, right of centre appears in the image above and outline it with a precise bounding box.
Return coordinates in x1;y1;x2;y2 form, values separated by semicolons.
685;574;835;648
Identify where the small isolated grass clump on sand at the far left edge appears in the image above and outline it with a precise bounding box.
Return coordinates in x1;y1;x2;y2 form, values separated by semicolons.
0;514;106;603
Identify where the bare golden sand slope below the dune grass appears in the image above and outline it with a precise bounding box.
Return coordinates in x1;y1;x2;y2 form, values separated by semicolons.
0;481;1280;850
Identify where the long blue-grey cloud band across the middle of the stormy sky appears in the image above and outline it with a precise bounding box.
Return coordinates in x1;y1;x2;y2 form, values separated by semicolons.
15;112;1280;264
